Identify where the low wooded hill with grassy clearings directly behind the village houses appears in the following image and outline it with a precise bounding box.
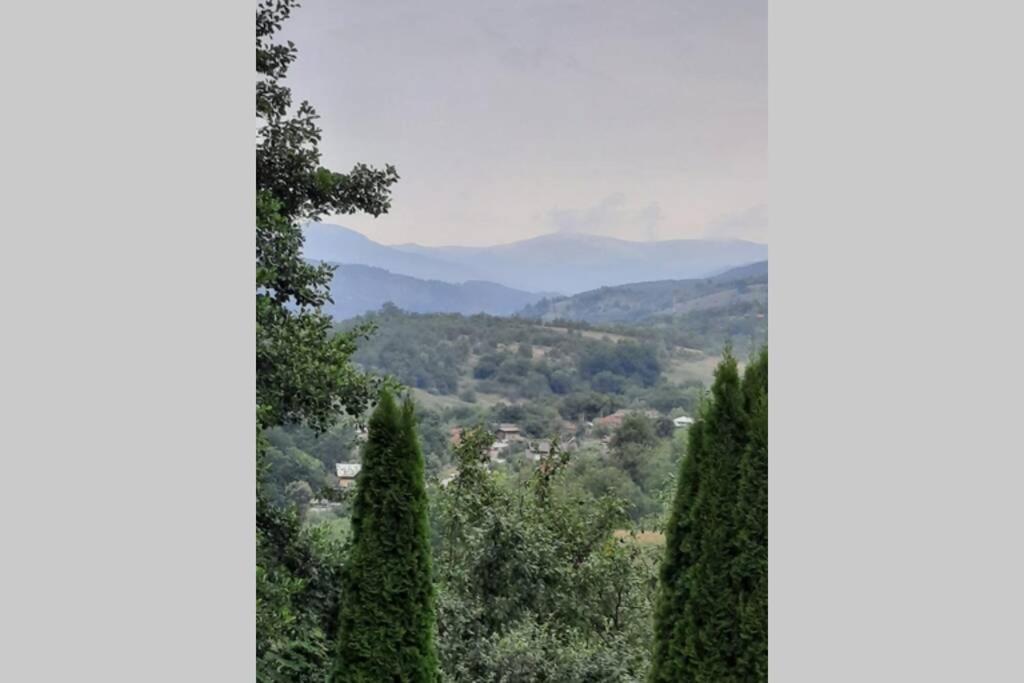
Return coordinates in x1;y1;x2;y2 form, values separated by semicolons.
339;306;701;423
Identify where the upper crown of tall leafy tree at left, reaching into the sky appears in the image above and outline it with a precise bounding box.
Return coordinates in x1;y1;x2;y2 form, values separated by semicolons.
256;0;398;430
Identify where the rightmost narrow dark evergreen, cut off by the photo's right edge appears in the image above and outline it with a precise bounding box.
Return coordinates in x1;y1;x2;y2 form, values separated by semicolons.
733;349;768;681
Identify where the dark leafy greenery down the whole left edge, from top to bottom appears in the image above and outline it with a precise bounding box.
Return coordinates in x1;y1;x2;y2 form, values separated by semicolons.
255;0;398;683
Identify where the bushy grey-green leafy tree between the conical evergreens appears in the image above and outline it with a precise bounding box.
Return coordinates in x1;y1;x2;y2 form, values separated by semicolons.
434;428;656;683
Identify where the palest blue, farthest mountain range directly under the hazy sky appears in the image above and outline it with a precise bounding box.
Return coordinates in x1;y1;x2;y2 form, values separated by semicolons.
304;223;768;295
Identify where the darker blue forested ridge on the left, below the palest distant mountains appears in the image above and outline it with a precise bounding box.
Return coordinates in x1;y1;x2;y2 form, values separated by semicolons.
325;265;544;321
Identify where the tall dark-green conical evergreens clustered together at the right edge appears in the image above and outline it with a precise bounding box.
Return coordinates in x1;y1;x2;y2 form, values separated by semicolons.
649;351;768;683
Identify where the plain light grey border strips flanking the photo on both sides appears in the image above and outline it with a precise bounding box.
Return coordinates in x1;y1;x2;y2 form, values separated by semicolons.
0;0;1024;683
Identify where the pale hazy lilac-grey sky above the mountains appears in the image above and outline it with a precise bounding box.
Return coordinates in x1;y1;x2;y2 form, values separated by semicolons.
283;0;768;245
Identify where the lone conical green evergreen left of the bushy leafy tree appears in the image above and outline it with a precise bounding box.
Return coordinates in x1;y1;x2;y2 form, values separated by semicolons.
332;392;438;683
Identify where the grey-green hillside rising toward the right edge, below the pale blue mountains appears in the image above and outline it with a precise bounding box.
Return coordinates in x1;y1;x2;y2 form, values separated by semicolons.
520;261;768;325
